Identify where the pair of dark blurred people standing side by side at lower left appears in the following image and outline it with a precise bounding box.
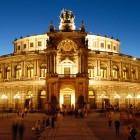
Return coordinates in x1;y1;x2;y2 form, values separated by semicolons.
12;120;25;140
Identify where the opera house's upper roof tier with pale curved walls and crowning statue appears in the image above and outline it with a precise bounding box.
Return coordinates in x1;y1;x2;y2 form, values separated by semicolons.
14;9;120;54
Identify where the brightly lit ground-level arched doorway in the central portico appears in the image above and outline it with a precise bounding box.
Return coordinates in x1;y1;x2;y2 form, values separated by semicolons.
60;87;75;109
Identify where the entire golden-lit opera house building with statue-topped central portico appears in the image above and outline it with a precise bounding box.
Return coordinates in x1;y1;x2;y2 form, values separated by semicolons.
0;9;140;110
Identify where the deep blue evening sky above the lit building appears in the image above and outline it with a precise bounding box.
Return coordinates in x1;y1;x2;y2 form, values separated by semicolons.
0;0;140;58
